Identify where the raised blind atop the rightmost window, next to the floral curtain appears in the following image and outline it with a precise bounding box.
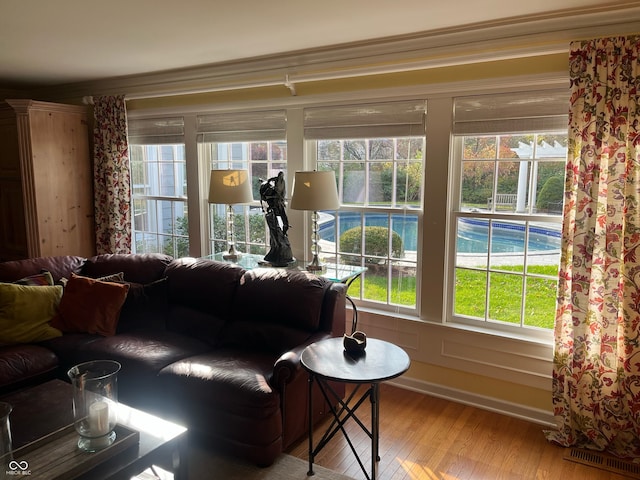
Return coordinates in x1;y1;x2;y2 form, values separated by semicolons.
453;89;569;135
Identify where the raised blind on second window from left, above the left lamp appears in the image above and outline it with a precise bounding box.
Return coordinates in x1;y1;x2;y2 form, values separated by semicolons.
196;110;287;143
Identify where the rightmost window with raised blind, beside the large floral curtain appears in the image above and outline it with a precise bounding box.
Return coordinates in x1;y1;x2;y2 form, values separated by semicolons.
450;91;567;333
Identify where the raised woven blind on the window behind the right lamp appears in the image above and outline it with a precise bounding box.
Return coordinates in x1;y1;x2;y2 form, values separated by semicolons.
304;100;426;140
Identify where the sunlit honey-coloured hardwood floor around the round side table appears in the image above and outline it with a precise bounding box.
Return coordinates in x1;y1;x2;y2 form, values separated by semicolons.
287;384;634;480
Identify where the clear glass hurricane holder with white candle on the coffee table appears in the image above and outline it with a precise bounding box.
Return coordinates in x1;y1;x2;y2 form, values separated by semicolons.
67;360;121;452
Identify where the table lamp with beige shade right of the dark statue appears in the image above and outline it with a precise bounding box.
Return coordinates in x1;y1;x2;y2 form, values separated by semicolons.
290;170;340;272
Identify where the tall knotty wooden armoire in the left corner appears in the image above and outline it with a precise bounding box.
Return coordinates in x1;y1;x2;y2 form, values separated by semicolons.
0;100;95;261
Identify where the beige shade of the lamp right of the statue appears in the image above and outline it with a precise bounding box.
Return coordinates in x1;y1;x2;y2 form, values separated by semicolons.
290;170;340;211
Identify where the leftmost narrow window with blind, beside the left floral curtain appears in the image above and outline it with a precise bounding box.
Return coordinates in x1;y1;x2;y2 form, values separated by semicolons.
129;117;189;257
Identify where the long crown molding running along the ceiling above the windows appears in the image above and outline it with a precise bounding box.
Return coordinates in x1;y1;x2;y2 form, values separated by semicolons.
29;1;640;100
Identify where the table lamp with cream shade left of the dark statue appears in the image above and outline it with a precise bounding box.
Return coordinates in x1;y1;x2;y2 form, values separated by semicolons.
209;170;253;261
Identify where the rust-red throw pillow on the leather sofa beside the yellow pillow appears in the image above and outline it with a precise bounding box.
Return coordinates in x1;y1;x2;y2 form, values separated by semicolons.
51;273;129;336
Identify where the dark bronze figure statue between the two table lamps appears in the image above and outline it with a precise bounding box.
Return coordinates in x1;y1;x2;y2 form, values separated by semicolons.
260;172;296;267
